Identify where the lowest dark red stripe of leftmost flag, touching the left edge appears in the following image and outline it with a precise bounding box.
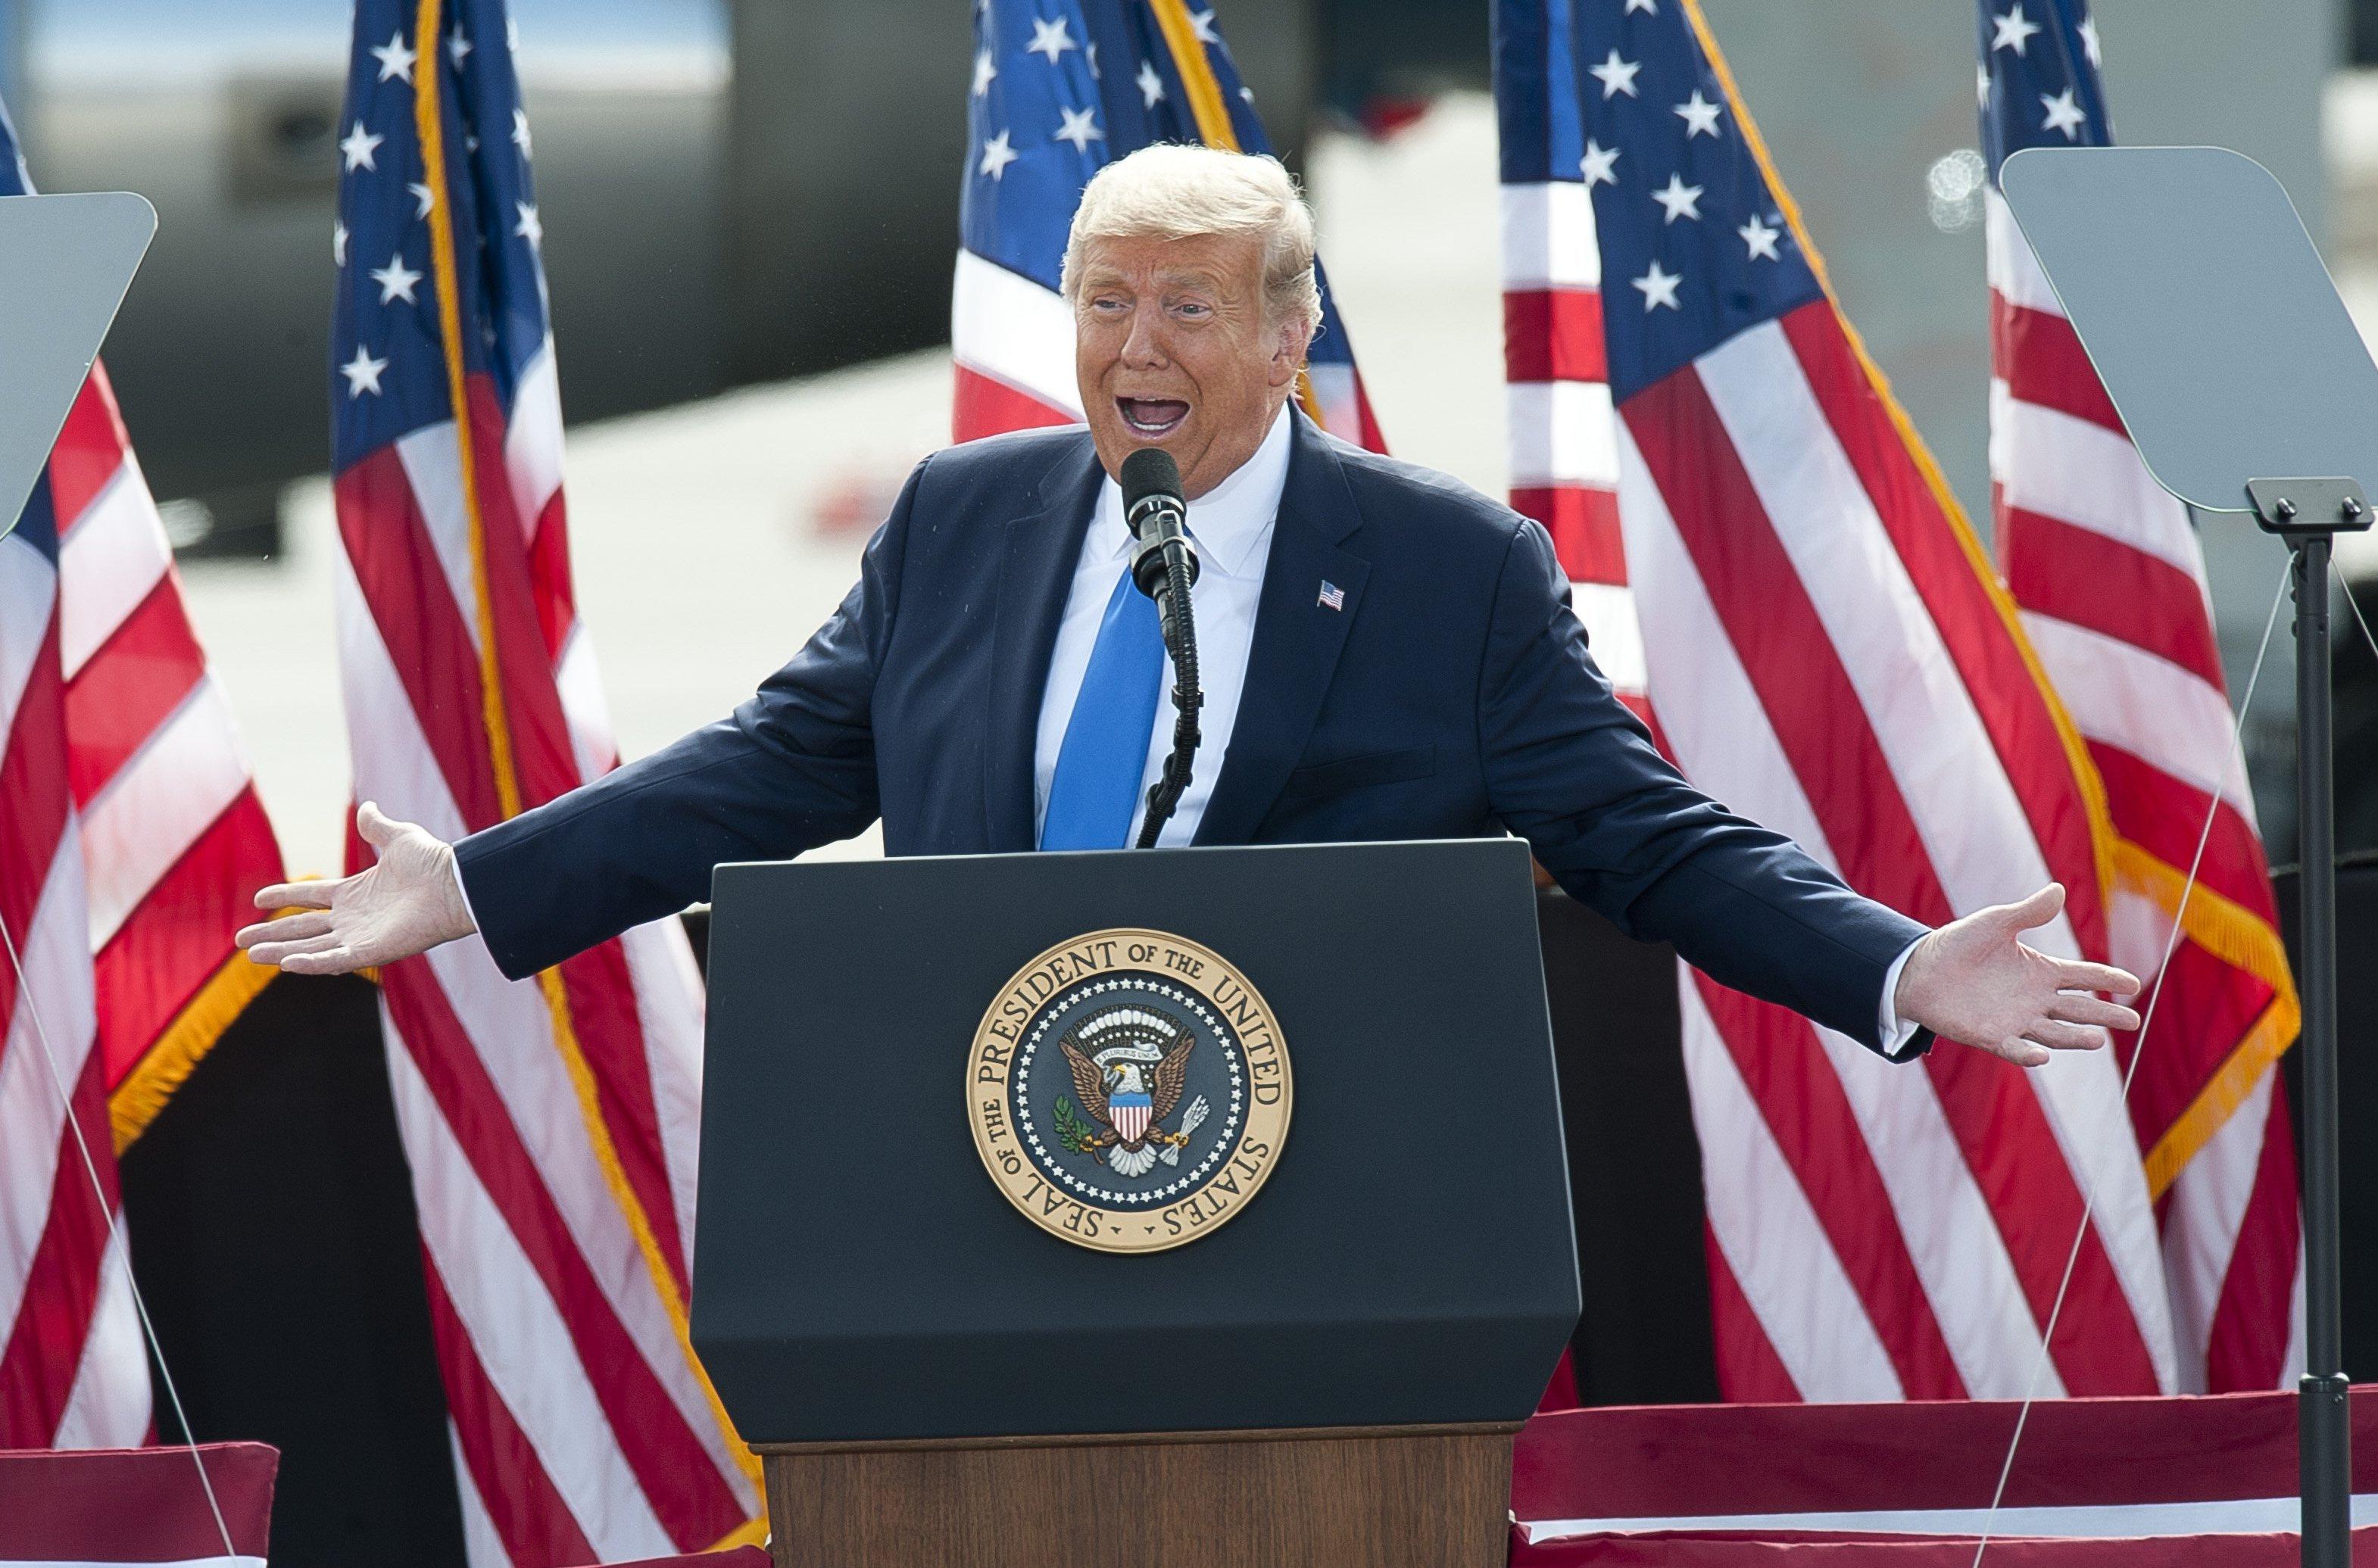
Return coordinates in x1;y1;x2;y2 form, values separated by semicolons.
0;1052;117;1449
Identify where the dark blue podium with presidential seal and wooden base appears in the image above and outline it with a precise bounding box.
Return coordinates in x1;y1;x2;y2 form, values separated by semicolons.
692;839;1579;1568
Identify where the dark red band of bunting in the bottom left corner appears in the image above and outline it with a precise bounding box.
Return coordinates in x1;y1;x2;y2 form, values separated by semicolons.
0;1442;281;1563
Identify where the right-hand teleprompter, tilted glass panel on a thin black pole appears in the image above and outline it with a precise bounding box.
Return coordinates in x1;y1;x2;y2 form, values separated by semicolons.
2002;148;2378;1568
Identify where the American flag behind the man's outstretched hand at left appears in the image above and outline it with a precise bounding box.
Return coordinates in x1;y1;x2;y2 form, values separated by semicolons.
330;0;763;1568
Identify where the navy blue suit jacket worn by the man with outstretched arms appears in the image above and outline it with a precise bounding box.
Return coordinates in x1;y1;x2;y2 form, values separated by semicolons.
457;416;1924;1046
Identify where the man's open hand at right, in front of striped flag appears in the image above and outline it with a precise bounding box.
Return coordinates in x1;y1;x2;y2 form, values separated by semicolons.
1893;881;2138;1067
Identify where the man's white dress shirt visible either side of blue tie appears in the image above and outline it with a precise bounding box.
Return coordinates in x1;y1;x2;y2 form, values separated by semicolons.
1032;407;1289;848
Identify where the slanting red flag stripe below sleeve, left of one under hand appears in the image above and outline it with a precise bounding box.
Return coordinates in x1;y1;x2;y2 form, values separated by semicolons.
1693;969;1967;1399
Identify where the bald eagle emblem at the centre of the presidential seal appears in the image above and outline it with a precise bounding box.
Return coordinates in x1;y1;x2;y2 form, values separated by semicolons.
1056;1005;1206;1176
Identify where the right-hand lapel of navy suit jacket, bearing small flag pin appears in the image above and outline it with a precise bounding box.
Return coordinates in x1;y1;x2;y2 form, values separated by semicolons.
1196;413;1370;843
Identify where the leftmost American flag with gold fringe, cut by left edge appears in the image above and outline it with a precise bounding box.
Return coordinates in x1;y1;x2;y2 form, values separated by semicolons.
0;92;281;1447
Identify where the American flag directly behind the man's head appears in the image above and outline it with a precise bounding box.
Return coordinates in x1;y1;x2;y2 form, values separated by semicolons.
949;0;1387;451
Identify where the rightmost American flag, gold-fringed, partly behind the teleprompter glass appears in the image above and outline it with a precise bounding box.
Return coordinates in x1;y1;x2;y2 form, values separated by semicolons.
1976;0;2302;1390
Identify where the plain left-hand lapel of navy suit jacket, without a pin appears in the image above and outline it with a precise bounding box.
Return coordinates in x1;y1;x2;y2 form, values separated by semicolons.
982;432;1106;853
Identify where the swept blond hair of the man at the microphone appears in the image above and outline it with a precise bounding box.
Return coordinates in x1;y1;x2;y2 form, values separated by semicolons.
1058;142;1322;338
